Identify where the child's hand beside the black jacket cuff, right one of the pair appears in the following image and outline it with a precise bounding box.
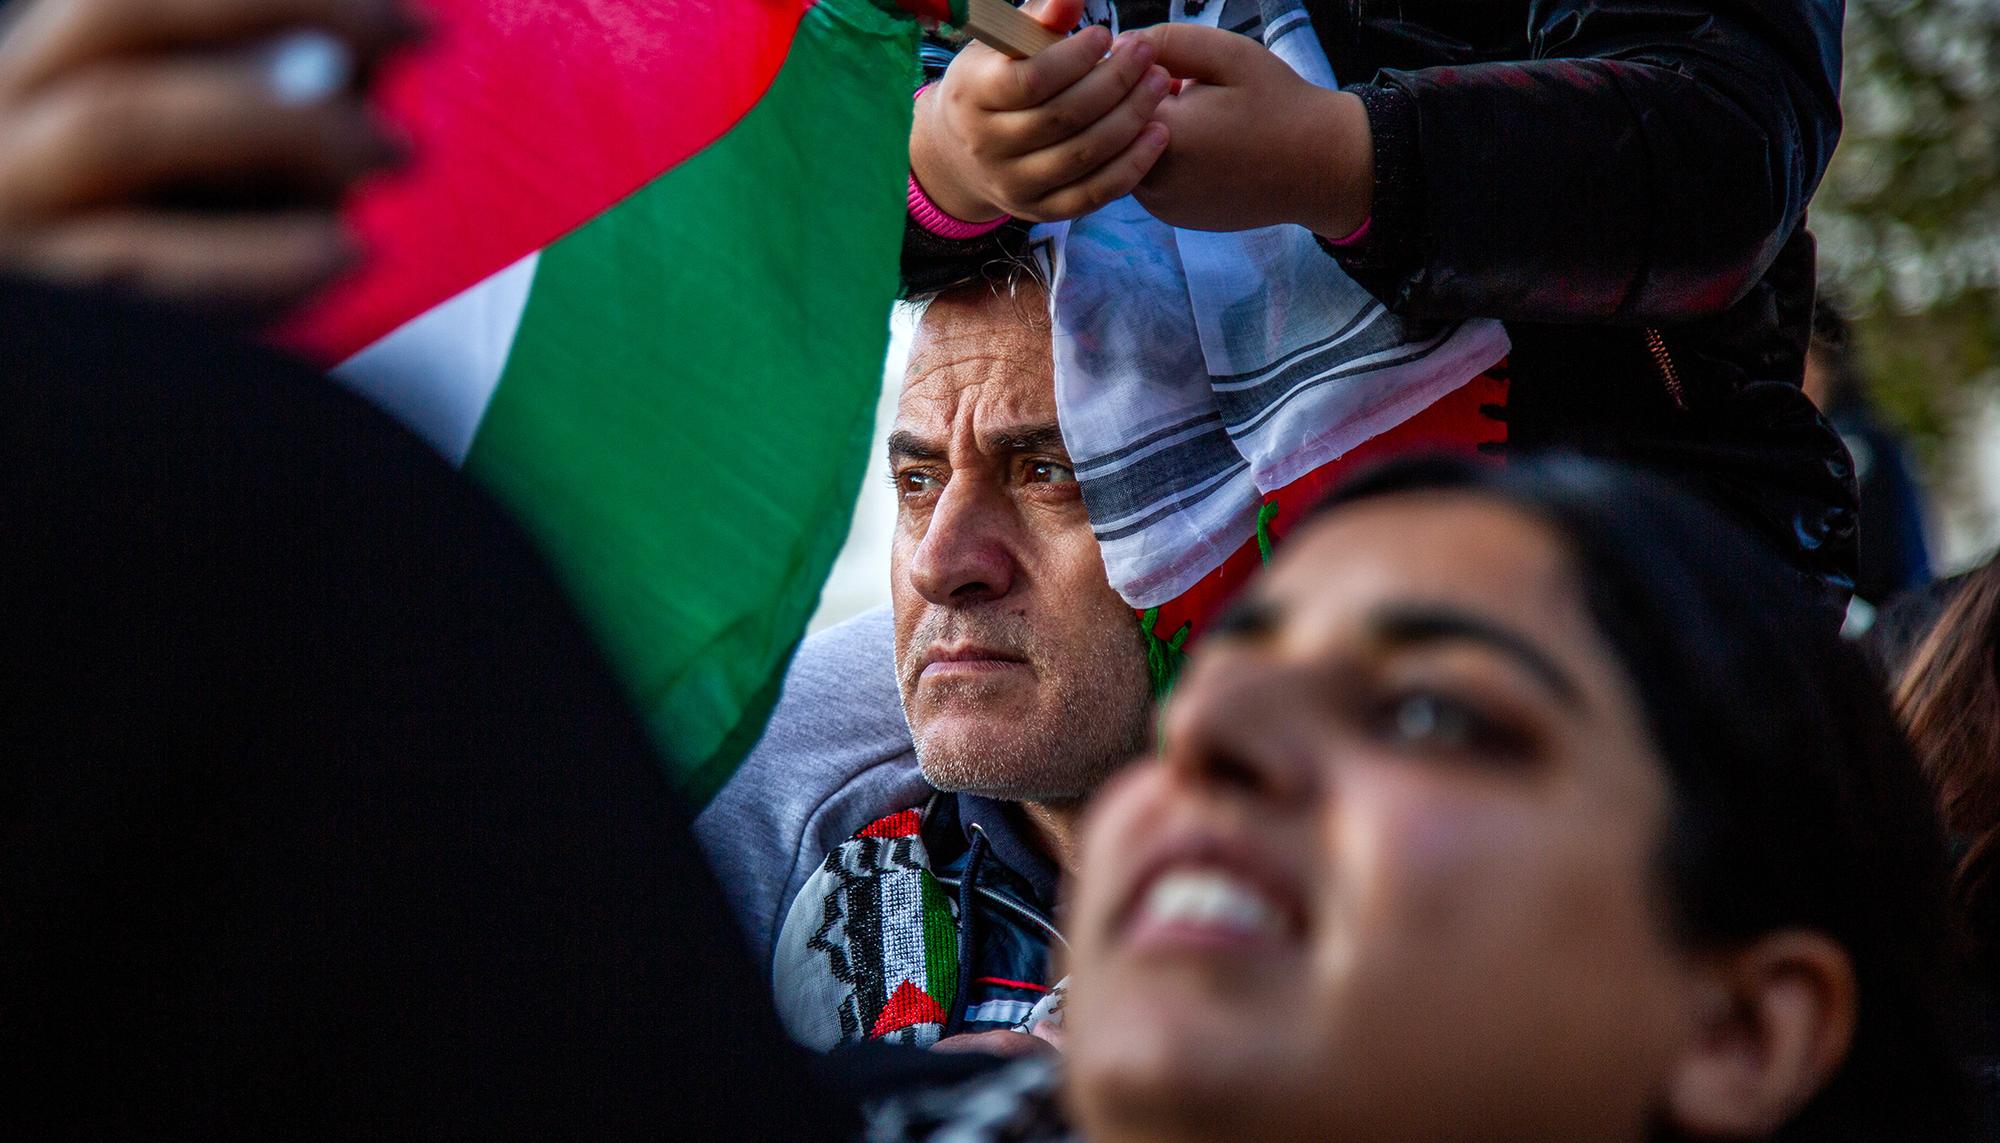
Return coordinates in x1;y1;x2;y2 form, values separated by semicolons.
1132;24;1374;238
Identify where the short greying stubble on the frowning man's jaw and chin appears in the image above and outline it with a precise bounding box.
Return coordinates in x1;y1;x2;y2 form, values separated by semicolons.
904;611;1152;801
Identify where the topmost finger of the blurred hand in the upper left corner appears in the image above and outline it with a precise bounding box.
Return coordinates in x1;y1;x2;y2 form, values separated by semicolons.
0;0;420;92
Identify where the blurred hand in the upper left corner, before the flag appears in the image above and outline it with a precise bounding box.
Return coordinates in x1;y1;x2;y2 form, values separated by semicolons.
0;0;418;316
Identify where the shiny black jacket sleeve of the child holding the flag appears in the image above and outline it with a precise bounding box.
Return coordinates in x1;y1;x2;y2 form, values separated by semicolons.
1322;0;1842;322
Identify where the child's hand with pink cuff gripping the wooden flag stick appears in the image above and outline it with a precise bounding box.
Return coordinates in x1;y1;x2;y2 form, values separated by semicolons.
910;0;1168;222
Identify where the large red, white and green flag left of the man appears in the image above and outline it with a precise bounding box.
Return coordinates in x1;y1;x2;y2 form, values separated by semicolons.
290;0;918;801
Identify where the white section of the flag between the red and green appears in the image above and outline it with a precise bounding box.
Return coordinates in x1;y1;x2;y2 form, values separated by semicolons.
334;254;542;464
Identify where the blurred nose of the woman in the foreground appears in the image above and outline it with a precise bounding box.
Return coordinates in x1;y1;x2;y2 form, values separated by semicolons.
1160;647;1324;807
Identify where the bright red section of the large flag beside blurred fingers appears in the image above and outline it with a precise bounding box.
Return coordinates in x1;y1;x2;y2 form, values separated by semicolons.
286;0;812;362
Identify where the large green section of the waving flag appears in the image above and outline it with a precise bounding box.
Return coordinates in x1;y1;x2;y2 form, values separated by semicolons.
466;0;918;805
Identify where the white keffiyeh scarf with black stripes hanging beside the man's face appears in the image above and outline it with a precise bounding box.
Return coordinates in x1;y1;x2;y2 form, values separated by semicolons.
1034;0;1508;639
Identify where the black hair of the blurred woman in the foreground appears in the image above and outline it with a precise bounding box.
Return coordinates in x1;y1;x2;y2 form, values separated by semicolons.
1320;456;1968;1143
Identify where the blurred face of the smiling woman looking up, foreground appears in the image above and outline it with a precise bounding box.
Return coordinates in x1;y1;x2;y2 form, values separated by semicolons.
1066;494;1696;1143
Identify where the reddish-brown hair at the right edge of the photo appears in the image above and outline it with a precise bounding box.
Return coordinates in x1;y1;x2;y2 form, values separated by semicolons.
1890;562;2000;977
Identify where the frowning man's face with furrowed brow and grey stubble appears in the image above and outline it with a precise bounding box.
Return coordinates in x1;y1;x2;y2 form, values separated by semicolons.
888;290;1150;801
